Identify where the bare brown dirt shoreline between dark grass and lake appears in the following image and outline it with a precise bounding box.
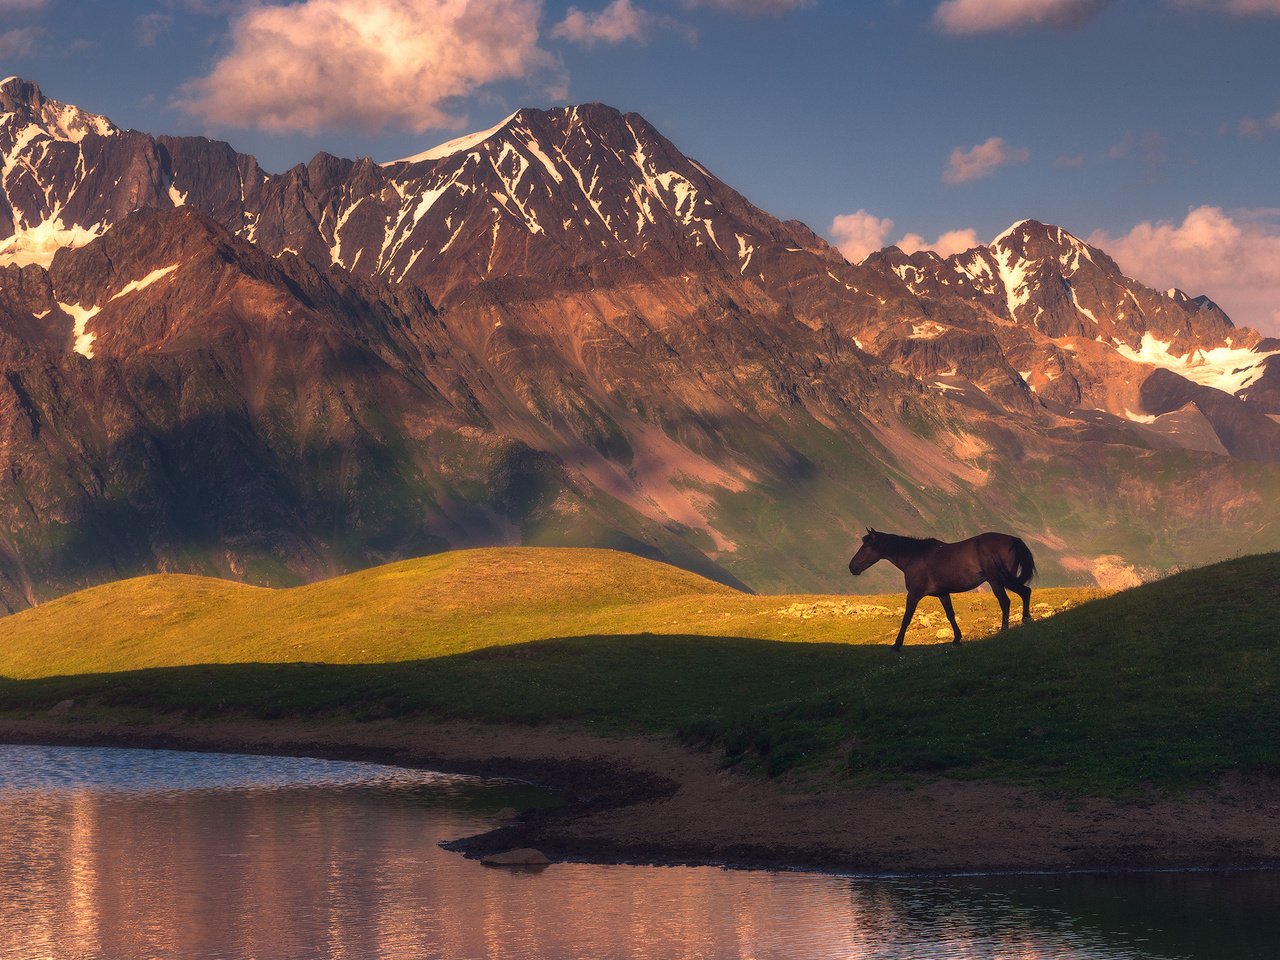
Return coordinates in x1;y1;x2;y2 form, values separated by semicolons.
0;710;1280;878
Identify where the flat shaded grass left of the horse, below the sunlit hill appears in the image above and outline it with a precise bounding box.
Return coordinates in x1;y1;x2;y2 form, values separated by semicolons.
0;634;901;727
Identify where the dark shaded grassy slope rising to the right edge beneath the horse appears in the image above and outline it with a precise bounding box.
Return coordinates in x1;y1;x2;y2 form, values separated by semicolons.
685;553;1280;792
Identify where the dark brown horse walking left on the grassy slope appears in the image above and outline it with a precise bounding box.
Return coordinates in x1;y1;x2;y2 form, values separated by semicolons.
849;527;1036;650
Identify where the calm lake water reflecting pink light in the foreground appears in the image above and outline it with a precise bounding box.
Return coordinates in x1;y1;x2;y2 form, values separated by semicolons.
0;746;1280;960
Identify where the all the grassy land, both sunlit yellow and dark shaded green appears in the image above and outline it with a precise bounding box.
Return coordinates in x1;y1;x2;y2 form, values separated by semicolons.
0;549;1280;794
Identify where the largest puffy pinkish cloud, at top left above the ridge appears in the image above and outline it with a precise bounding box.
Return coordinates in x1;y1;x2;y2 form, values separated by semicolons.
178;0;556;133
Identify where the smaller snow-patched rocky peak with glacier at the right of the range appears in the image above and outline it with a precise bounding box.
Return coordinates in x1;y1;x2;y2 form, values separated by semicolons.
865;220;1280;422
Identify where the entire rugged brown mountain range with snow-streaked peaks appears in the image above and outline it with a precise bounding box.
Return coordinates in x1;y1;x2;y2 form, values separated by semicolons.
0;78;1280;609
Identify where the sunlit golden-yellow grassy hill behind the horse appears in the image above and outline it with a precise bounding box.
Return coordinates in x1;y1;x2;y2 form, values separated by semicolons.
0;548;1093;678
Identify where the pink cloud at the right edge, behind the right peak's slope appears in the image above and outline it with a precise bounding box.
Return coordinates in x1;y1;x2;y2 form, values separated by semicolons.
1089;206;1280;335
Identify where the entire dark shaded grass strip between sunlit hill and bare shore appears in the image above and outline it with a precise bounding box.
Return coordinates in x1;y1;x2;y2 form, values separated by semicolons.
0;583;1280;794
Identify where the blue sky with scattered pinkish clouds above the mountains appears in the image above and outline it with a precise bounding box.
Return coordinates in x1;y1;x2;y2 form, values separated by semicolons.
0;0;1280;335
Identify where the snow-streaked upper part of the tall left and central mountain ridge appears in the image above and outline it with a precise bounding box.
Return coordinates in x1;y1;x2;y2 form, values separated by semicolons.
0;85;824;302
